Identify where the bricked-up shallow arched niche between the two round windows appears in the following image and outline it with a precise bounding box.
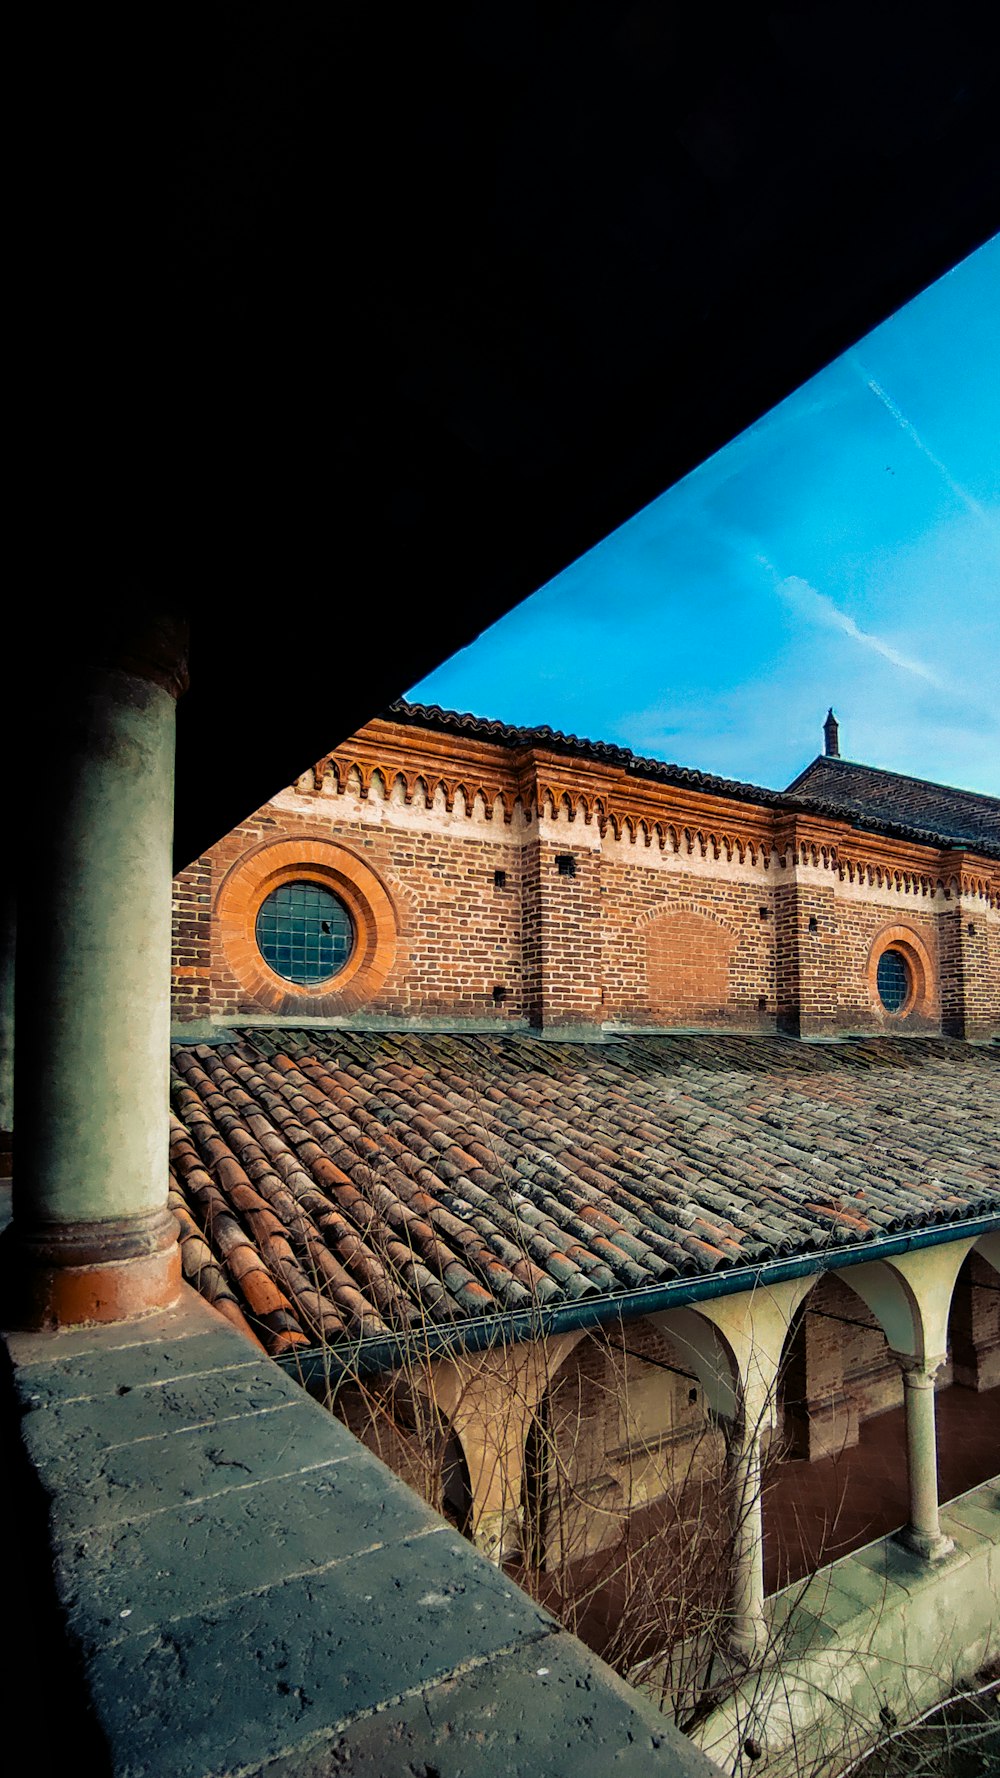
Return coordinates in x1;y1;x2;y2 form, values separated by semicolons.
644;909;737;1024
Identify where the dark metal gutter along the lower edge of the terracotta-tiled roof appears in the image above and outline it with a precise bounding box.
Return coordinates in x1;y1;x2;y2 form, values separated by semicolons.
276;1211;1000;1389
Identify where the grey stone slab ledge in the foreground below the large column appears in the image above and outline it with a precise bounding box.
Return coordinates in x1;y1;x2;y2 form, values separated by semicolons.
7;1291;717;1778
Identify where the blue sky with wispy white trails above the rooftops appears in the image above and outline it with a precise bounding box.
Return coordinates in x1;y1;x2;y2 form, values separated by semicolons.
407;236;1000;795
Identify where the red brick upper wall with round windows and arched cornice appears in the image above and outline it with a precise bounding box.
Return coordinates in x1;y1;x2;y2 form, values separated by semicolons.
174;718;1000;1037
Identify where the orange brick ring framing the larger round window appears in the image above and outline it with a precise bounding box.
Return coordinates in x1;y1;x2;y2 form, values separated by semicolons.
215;837;399;1017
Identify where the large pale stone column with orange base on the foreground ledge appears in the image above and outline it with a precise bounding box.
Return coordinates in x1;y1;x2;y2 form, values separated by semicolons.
5;618;185;1326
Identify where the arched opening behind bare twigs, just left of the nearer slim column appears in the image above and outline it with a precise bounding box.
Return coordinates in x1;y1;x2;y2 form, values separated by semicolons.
516;1316;731;1671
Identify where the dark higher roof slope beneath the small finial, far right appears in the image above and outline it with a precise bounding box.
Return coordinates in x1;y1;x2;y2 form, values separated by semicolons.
786;754;1000;852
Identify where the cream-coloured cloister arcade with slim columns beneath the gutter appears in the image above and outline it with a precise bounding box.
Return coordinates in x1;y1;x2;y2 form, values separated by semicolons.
333;1232;1000;1659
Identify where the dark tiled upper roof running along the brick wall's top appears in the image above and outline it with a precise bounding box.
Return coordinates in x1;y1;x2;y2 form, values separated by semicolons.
383;699;1000;859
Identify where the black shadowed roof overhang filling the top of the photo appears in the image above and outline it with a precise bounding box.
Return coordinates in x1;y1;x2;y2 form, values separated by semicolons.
23;4;1000;864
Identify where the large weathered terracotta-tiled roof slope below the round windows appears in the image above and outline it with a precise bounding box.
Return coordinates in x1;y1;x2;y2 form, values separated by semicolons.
171;1029;1000;1353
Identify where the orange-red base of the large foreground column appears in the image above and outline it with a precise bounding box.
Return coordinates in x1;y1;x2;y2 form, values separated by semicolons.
0;1211;181;1332
